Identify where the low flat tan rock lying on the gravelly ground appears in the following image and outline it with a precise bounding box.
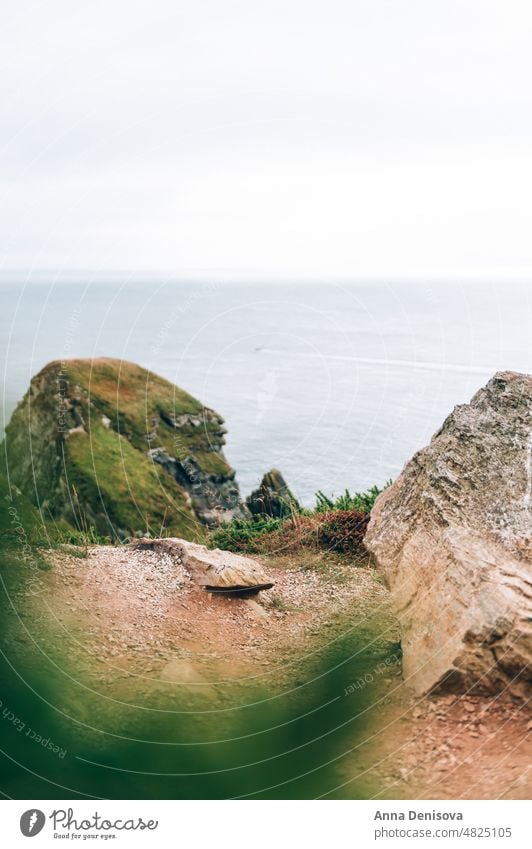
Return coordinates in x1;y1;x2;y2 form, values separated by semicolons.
134;537;273;593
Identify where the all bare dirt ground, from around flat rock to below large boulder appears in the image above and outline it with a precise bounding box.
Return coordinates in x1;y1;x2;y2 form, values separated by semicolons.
3;546;532;799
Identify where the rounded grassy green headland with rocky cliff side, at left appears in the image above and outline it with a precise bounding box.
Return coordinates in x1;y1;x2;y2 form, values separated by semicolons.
2;358;246;539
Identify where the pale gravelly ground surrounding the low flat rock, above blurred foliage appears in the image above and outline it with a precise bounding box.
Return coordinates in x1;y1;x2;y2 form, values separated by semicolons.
34;546;390;692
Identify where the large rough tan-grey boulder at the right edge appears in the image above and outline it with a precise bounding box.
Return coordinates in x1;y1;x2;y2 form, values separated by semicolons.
365;372;532;696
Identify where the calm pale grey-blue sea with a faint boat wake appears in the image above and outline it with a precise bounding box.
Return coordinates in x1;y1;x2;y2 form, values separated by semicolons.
0;282;532;503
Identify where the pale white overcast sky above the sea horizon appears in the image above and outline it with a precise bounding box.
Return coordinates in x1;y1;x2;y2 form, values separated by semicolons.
0;0;532;278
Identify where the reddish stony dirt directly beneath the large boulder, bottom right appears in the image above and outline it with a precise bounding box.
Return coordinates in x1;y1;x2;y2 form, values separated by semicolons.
339;683;532;799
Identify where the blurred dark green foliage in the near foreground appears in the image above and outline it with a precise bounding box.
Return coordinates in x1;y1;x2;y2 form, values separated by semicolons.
0;540;397;799
